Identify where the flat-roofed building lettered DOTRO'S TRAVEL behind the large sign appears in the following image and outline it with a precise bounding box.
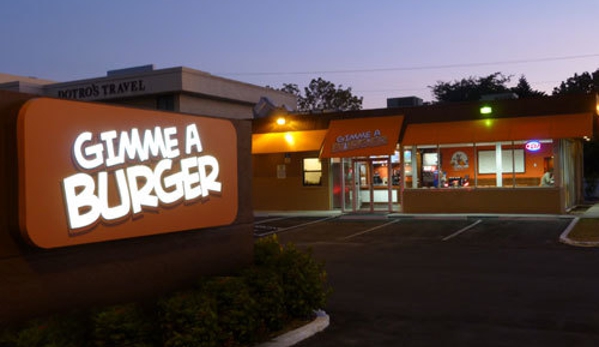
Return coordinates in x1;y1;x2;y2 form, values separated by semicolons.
0;65;297;119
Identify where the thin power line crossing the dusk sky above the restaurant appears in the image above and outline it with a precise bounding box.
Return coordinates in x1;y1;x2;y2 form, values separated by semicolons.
217;53;599;76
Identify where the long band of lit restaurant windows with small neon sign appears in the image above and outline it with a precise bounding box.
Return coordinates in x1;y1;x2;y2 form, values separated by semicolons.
403;139;555;188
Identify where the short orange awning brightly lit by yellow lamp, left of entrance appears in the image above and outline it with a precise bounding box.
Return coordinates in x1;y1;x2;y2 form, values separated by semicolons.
252;130;327;154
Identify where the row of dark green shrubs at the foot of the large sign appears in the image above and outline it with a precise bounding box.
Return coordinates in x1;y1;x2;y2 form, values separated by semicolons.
0;236;331;347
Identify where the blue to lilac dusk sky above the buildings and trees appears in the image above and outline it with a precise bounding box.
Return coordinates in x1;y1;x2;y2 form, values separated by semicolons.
0;0;599;109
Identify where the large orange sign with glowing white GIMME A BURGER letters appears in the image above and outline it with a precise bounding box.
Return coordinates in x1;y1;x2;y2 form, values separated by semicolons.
18;98;238;248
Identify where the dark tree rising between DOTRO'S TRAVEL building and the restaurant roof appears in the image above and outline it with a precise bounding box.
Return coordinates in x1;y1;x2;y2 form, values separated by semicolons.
279;77;363;112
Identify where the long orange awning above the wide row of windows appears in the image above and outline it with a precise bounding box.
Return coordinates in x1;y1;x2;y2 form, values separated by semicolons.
401;113;593;146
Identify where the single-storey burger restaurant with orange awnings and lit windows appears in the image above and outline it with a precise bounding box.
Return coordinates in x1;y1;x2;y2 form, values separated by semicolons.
252;94;599;214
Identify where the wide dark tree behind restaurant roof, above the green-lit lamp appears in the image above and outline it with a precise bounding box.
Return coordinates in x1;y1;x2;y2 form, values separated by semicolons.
429;72;545;102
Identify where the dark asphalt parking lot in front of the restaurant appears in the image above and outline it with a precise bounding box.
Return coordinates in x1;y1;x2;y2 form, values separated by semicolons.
256;215;599;346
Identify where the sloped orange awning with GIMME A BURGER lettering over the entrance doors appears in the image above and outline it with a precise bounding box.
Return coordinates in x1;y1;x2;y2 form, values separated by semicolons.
320;116;403;158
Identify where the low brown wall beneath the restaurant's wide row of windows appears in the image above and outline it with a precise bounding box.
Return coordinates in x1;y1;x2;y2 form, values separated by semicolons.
402;187;565;214
